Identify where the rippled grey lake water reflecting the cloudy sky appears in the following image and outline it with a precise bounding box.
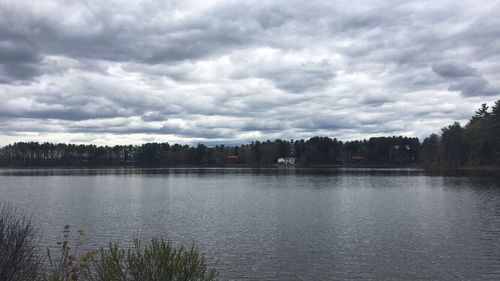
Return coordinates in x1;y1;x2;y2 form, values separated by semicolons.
0;169;500;280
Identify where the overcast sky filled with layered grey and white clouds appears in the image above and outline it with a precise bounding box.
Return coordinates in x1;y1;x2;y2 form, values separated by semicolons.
0;0;500;145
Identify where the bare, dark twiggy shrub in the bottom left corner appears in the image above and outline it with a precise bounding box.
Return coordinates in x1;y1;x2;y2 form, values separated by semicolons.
0;205;42;281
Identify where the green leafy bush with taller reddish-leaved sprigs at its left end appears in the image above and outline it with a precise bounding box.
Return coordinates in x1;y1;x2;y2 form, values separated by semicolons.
45;225;217;281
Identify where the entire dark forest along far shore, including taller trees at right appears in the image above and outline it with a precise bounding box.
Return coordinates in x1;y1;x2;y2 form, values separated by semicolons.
0;100;500;167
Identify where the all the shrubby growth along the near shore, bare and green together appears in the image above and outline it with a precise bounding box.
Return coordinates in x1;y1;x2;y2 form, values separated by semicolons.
0;203;218;281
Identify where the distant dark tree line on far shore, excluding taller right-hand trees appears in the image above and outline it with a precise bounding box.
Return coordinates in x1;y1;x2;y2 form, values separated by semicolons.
0;136;420;167
